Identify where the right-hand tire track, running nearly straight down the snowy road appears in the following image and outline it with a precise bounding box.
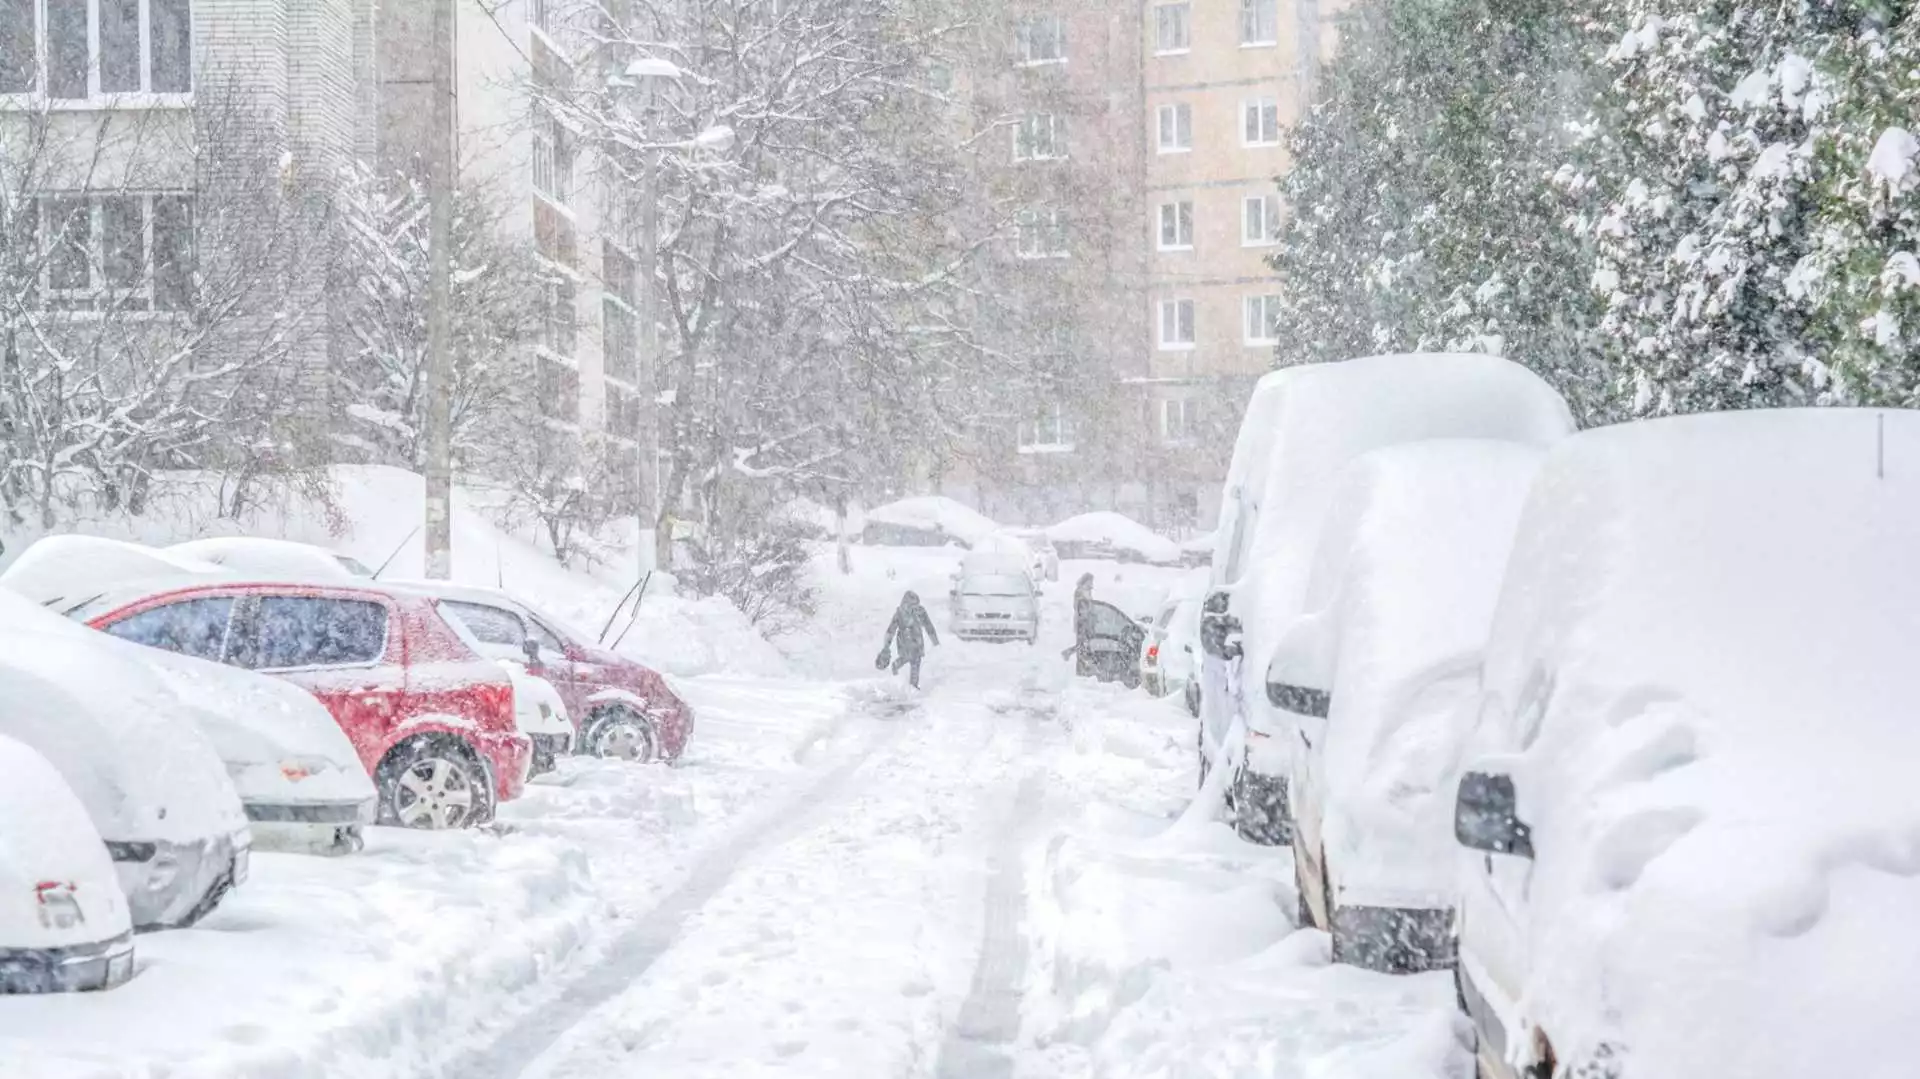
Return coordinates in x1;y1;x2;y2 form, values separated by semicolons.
935;705;1052;1079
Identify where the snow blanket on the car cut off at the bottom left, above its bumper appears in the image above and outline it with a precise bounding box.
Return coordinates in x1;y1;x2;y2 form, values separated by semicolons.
0;735;132;948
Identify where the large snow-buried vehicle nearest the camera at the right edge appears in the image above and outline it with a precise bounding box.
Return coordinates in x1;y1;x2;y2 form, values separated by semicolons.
1455;409;1920;1079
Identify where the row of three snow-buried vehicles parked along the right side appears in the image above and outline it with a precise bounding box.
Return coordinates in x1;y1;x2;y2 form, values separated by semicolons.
1169;355;1920;1079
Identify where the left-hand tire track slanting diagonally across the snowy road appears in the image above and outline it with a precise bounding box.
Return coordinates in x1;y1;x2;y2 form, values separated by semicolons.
438;703;920;1079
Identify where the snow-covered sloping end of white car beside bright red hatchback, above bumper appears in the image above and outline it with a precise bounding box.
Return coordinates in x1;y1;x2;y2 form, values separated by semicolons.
140;649;374;804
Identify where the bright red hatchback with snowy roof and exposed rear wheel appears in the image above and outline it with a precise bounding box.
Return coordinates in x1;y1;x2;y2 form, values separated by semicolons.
65;582;532;827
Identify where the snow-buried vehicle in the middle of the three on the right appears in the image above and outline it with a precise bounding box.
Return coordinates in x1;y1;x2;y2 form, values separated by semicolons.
1265;440;1542;973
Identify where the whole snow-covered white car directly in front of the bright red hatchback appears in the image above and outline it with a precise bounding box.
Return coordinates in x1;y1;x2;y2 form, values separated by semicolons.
125;641;378;854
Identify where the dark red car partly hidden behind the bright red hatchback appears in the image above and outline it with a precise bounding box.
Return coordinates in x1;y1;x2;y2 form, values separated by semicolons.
396;582;693;760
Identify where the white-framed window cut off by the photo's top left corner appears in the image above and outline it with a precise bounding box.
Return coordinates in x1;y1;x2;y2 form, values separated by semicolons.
0;0;194;102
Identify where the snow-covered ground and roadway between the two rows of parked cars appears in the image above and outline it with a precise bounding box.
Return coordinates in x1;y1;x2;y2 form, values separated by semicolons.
0;549;1467;1079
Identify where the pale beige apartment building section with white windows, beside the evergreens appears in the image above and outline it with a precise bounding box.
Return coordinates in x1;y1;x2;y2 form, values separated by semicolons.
1137;0;1334;518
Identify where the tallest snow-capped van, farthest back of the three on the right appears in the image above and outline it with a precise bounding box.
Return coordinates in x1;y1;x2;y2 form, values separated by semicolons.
1198;353;1572;843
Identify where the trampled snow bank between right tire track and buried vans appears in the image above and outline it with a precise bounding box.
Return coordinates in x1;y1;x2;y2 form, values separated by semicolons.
1016;685;1465;1079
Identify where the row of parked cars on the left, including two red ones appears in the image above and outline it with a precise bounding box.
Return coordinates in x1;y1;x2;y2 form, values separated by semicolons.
0;536;693;993
